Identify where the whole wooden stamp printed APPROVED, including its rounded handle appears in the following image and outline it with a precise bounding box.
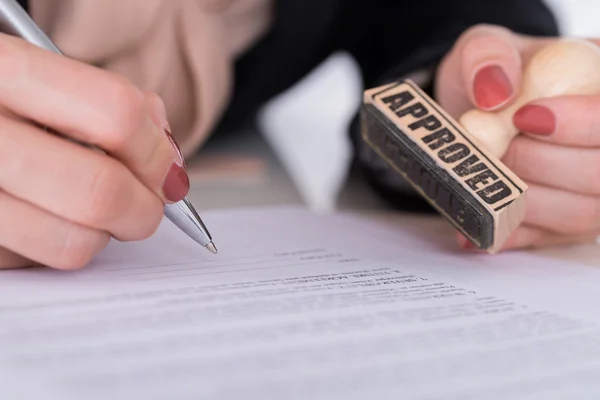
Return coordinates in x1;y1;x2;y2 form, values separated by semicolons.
361;39;600;253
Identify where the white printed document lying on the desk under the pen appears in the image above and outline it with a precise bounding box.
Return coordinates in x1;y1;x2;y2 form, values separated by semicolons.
0;208;600;400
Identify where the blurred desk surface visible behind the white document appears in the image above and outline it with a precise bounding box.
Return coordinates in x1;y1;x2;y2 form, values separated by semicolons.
188;129;600;267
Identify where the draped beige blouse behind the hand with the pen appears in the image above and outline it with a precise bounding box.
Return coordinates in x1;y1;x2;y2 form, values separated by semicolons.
30;0;272;155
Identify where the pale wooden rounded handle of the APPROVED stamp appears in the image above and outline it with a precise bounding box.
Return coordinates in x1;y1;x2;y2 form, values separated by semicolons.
459;39;600;158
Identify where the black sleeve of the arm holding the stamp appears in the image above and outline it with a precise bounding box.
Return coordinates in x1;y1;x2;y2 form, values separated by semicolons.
342;0;558;211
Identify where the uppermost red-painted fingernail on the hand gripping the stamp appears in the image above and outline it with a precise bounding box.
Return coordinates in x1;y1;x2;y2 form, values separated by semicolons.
473;65;513;110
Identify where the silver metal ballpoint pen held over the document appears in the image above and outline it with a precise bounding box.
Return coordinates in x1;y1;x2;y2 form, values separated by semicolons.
0;0;217;254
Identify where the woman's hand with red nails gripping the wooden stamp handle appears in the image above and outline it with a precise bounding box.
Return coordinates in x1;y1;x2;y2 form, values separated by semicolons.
436;26;600;249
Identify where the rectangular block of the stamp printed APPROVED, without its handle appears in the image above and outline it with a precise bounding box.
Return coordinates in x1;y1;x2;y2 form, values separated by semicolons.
361;81;527;252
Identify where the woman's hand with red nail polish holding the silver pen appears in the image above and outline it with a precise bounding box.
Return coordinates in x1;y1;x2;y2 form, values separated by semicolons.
0;35;189;269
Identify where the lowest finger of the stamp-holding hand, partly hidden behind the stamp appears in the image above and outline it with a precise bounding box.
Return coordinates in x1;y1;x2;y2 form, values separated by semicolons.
456;225;597;251
